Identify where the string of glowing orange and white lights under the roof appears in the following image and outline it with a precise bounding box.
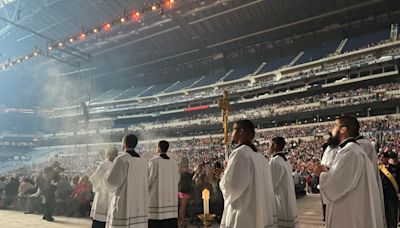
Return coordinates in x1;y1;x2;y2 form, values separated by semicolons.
0;0;176;70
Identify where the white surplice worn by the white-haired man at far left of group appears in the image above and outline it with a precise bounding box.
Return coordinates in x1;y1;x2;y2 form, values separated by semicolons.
90;161;113;222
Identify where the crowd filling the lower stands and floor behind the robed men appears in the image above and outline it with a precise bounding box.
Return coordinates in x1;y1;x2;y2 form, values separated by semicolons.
0;117;400;221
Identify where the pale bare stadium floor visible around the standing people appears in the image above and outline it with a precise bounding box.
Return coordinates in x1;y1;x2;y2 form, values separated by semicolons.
0;194;323;228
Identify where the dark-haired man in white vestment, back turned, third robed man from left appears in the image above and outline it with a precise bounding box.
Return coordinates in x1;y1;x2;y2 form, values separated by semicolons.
149;140;179;228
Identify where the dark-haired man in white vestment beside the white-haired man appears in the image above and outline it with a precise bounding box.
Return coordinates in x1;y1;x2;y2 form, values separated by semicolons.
104;134;148;228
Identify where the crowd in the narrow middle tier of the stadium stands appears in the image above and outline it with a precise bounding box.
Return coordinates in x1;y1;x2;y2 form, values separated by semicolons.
125;83;400;133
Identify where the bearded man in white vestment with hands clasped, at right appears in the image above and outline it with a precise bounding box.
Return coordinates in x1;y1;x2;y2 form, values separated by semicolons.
314;116;384;228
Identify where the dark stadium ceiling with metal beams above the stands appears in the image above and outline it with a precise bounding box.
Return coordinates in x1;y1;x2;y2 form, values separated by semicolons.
0;0;400;77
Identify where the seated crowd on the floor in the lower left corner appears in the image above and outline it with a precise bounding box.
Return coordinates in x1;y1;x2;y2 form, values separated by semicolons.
0;161;94;220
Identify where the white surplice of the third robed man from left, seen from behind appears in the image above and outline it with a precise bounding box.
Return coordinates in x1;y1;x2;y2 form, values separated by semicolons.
149;157;179;220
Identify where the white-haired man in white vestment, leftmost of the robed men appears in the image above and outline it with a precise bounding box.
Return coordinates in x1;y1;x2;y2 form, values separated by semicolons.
90;147;118;228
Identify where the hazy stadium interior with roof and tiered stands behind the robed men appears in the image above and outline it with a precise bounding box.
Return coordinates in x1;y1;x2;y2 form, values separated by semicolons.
0;0;400;226
